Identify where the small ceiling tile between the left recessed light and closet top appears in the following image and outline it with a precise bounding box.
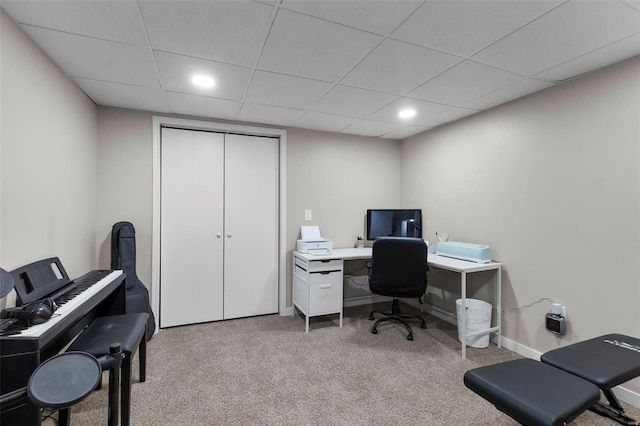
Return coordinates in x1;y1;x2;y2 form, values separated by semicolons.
167;92;240;120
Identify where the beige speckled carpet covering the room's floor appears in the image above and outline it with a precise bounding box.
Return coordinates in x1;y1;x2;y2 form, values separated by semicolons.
45;304;640;426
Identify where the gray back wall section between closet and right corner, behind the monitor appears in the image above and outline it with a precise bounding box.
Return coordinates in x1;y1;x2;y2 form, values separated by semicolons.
287;129;400;305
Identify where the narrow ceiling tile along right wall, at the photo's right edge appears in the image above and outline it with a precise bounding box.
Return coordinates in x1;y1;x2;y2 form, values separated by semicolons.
536;34;640;81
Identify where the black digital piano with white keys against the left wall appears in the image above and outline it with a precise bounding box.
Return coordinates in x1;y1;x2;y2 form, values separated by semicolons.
0;258;126;426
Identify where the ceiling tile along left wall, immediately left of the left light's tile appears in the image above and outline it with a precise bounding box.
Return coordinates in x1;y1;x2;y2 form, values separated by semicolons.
22;25;160;87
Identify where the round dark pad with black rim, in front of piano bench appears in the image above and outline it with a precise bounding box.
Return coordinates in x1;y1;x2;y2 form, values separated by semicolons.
27;352;102;409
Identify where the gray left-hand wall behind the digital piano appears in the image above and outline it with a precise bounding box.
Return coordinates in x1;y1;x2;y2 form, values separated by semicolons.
0;12;98;306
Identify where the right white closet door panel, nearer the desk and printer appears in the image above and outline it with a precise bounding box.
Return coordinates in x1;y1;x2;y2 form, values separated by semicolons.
224;135;278;319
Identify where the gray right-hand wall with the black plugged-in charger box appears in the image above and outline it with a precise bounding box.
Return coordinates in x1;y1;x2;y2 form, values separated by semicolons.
401;58;640;389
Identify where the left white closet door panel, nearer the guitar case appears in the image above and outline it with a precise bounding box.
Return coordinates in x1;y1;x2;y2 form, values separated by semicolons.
160;128;224;327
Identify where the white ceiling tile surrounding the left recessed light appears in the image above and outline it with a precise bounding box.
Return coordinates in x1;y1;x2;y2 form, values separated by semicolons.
155;52;251;101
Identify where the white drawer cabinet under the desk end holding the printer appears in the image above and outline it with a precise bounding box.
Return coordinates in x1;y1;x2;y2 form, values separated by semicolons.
293;252;342;333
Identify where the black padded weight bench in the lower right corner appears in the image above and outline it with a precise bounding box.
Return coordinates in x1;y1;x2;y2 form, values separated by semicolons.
464;334;640;426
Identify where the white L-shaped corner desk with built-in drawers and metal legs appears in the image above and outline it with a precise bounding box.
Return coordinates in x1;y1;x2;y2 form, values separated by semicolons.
293;247;502;358
